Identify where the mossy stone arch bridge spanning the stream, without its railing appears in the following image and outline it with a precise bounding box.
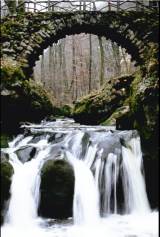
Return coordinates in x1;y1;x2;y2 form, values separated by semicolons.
1;10;158;77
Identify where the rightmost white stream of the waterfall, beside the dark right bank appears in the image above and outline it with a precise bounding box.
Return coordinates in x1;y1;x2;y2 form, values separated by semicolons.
122;138;150;213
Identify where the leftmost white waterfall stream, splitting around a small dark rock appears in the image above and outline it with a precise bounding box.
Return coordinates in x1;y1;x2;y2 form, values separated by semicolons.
3;136;51;228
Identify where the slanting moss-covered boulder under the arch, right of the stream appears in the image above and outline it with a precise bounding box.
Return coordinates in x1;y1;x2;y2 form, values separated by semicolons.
73;75;134;124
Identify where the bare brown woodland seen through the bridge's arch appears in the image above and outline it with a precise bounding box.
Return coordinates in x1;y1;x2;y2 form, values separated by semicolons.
33;33;136;106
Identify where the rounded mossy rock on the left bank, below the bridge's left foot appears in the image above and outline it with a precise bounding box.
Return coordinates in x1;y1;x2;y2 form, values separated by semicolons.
1;80;54;132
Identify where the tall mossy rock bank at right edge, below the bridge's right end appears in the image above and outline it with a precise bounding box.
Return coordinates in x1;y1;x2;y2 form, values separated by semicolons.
116;69;159;161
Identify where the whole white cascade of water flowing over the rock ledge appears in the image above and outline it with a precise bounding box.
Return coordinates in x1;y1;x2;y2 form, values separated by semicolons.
1;120;158;237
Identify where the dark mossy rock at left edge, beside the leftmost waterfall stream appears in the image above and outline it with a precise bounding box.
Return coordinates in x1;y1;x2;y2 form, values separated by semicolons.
1;156;13;224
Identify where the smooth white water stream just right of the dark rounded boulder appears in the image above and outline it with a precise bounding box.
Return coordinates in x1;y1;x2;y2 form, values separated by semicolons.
67;152;99;224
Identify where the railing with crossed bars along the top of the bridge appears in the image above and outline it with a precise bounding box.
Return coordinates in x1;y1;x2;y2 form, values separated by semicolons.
1;0;159;17
